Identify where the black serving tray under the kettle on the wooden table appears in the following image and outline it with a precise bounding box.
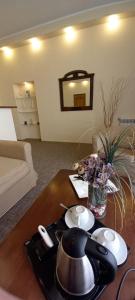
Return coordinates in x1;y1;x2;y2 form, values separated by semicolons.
25;215;127;300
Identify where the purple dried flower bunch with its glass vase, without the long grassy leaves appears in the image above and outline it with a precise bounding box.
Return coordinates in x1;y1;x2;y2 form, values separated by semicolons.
74;154;114;219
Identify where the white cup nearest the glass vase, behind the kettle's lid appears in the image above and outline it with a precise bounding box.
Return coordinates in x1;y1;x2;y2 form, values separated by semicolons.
71;205;89;227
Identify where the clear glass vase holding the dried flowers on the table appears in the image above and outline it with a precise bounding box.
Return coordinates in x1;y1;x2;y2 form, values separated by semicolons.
87;184;107;219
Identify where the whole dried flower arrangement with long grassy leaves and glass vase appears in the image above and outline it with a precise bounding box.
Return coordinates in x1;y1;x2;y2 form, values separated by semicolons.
73;129;135;226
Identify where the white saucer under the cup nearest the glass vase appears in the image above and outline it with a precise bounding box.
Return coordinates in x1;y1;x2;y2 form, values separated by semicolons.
65;205;95;231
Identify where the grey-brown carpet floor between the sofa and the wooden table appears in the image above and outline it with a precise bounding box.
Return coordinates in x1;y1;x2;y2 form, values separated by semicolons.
0;140;92;241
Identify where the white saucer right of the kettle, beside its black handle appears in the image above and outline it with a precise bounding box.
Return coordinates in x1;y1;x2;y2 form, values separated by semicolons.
91;227;128;266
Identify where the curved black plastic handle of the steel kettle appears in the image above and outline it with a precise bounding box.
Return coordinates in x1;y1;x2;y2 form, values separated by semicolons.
85;238;117;284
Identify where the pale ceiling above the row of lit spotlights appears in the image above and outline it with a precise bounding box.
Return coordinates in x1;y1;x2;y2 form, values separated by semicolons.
0;0;135;46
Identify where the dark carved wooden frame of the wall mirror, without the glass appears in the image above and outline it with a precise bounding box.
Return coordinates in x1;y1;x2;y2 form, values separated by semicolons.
59;70;94;111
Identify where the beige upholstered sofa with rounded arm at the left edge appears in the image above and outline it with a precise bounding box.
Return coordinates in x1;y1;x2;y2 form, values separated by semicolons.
0;140;37;217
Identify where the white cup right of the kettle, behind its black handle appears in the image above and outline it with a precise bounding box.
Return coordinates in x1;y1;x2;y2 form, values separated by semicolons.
96;229;120;256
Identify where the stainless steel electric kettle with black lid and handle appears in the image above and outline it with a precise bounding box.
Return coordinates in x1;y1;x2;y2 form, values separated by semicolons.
56;227;117;296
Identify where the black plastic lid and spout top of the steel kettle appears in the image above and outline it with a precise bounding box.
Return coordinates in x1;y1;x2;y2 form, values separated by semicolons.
62;227;88;258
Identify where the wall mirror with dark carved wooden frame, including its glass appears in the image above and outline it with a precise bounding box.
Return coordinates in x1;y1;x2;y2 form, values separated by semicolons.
59;70;94;111
